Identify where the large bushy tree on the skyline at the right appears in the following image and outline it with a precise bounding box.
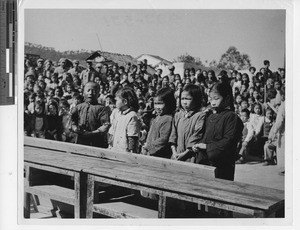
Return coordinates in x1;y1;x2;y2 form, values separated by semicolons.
218;46;251;70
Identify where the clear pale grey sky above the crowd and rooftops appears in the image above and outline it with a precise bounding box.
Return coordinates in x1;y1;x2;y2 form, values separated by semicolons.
25;9;286;70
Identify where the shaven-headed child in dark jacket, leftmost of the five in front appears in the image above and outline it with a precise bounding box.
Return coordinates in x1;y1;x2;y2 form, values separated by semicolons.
71;82;110;148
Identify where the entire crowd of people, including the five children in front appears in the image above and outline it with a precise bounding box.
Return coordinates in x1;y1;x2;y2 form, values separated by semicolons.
24;58;285;180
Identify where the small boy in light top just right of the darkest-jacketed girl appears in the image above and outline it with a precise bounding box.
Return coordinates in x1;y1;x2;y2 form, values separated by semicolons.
235;109;254;164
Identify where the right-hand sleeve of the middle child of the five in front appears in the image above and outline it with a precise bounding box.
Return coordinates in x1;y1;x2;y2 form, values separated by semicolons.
147;119;173;154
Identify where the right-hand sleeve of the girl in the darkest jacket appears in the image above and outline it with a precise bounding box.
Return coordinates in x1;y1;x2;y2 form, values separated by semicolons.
206;114;243;160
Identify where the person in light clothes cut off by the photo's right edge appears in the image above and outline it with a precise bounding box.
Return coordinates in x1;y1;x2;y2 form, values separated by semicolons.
270;87;285;176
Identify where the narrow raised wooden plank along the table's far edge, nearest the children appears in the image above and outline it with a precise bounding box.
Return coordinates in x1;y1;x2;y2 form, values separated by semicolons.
24;137;216;178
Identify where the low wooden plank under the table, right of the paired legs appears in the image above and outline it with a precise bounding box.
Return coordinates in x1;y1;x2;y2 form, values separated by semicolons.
94;202;158;218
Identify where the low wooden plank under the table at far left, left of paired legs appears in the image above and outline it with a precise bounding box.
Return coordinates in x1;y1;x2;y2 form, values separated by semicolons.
25;185;75;205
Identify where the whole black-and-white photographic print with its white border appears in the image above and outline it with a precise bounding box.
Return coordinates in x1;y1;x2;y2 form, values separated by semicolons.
0;0;295;225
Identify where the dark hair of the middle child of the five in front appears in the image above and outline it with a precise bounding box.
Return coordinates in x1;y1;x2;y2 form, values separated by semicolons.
155;88;176;114
